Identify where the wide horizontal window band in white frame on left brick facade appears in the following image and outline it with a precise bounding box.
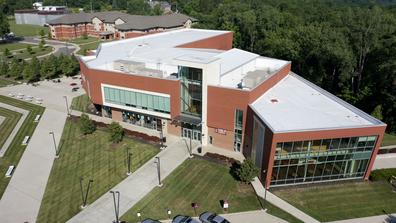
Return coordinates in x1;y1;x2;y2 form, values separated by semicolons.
103;87;170;114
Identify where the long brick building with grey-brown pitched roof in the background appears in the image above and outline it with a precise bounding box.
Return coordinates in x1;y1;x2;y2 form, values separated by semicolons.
48;11;196;39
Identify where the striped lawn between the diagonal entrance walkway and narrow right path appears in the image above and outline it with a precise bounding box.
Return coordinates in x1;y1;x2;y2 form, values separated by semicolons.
122;158;298;222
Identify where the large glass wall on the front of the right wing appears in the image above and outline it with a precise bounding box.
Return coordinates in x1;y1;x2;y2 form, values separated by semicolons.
271;136;377;185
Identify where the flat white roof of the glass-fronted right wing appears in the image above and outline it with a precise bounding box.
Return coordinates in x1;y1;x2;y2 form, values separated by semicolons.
250;73;385;132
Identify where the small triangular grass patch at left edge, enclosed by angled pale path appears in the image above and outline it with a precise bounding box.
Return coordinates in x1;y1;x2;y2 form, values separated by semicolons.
0;107;22;148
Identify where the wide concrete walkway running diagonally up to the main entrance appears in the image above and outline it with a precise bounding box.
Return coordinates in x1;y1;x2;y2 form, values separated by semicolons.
68;137;189;223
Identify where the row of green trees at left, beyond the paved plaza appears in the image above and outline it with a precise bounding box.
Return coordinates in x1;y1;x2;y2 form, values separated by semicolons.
0;54;79;82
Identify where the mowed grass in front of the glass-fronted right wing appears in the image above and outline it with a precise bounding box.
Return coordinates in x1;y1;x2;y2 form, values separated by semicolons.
274;181;396;222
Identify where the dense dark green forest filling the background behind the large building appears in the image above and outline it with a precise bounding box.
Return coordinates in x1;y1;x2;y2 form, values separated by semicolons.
5;0;396;132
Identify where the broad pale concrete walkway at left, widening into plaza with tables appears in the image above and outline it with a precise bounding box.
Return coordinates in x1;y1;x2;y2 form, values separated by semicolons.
0;78;81;223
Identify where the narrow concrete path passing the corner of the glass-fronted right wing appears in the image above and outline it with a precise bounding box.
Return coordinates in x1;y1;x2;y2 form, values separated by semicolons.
252;177;319;223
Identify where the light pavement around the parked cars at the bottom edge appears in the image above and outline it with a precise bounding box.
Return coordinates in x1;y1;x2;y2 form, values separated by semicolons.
161;210;287;223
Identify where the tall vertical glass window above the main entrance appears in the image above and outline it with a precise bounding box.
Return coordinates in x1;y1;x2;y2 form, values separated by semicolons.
178;66;202;117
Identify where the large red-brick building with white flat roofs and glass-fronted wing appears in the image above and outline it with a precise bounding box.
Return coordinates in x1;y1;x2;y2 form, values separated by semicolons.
80;29;386;187
